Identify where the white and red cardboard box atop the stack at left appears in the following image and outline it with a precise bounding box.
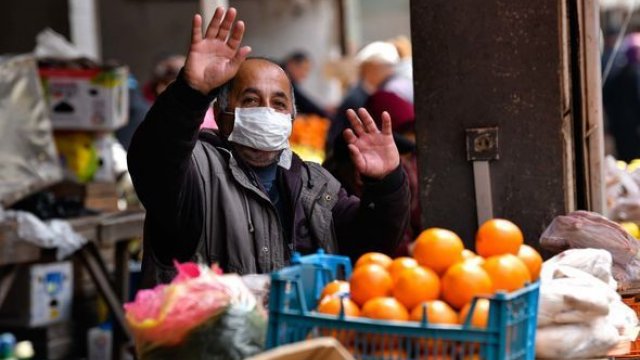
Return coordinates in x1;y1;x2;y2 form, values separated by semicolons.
40;66;129;131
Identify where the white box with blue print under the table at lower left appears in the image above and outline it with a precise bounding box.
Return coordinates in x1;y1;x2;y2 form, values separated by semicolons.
0;261;73;327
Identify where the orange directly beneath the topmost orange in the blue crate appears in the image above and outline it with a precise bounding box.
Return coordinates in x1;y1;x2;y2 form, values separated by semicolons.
482;254;531;292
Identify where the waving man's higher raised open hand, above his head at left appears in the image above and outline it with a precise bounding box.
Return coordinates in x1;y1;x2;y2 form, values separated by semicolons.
184;7;251;95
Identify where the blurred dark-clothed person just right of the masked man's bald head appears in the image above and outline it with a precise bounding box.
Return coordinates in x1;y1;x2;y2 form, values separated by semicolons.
284;51;329;118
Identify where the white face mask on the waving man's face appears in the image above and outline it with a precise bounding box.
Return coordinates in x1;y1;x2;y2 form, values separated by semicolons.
229;107;292;151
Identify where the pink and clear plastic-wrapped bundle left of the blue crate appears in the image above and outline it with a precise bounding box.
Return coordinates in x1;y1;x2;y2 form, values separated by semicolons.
124;263;266;360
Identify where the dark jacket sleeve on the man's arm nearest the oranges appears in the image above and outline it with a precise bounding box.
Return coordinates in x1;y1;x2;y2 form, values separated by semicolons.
333;166;411;261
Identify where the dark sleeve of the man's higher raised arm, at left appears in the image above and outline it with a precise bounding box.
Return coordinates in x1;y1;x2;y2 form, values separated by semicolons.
128;74;215;264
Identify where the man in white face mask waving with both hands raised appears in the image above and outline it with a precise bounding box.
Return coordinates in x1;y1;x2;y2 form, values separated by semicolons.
129;8;409;287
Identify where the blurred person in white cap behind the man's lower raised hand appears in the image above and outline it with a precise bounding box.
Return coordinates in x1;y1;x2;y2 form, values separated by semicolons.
326;41;400;158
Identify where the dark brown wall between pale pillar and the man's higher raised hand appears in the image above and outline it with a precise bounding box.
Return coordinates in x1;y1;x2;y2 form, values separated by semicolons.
99;0;199;82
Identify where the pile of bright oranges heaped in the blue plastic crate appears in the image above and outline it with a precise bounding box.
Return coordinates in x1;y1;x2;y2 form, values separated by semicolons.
317;219;542;328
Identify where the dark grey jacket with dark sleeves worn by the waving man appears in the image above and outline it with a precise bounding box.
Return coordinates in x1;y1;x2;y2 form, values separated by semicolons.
129;73;410;287
